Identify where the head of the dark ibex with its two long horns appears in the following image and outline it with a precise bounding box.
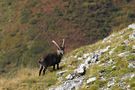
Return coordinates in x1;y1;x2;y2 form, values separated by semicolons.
52;39;65;55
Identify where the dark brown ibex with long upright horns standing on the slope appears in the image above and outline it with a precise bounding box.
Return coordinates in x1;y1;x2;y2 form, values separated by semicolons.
39;39;65;76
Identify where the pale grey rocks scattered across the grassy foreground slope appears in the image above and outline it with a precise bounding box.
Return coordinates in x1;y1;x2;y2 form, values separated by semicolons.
50;24;135;90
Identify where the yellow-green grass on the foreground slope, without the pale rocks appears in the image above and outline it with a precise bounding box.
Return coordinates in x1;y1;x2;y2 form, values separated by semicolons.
0;23;135;90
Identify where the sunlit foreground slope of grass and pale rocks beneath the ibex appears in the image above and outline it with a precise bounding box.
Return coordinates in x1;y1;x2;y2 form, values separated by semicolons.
0;24;135;90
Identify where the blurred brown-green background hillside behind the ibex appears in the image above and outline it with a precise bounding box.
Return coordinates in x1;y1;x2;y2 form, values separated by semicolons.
0;0;135;79
